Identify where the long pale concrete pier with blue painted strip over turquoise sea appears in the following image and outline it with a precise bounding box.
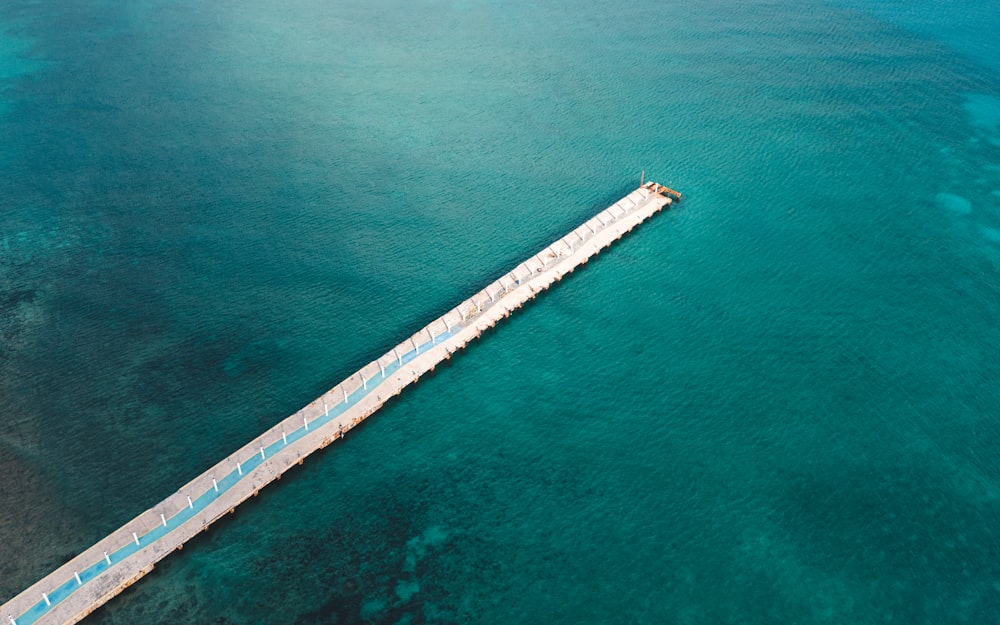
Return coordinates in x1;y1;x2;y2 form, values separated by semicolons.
0;182;680;625
